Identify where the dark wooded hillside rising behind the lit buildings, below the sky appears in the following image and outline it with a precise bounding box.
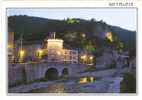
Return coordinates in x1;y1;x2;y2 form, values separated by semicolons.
8;16;136;50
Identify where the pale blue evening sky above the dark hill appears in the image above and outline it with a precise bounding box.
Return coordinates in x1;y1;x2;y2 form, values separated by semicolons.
7;8;137;30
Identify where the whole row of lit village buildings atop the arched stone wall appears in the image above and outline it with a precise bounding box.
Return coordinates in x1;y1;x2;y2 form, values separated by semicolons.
8;32;94;65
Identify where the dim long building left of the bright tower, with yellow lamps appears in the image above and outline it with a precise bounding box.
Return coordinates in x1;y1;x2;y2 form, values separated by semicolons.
15;41;44;61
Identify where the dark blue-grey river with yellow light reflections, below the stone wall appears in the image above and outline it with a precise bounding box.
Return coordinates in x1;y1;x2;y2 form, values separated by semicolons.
9;77;122;93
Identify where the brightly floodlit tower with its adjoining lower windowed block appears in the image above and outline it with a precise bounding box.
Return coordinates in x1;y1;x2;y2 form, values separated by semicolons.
47;34;78;64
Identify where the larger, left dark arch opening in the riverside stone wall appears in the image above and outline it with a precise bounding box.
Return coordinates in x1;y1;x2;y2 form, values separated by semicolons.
45;68;58;80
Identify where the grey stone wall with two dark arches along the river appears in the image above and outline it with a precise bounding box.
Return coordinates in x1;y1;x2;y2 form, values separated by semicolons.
8;63;86;84
